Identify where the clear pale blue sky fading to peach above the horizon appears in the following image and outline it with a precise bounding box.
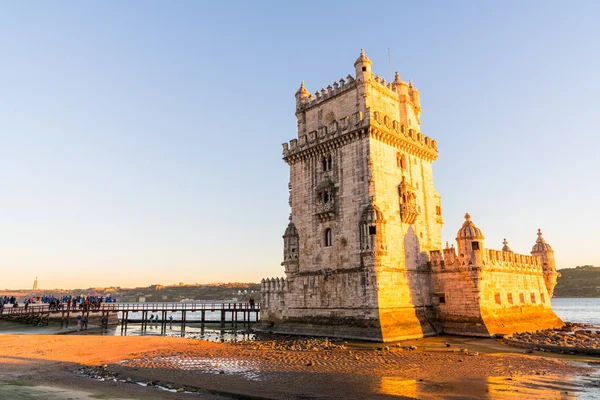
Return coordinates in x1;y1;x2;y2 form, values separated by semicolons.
0;1;600;289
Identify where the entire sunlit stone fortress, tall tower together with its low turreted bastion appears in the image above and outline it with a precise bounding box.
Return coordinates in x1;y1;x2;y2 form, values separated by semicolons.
257;51;562;341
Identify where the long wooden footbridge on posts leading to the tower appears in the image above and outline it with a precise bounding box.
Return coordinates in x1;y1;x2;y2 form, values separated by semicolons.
0;302;260;333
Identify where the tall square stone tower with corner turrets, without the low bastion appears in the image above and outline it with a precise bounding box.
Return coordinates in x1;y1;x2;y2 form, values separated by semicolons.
261;51;442;340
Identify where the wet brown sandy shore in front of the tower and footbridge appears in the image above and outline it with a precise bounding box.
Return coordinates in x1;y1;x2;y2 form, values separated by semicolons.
0;335;600;399
